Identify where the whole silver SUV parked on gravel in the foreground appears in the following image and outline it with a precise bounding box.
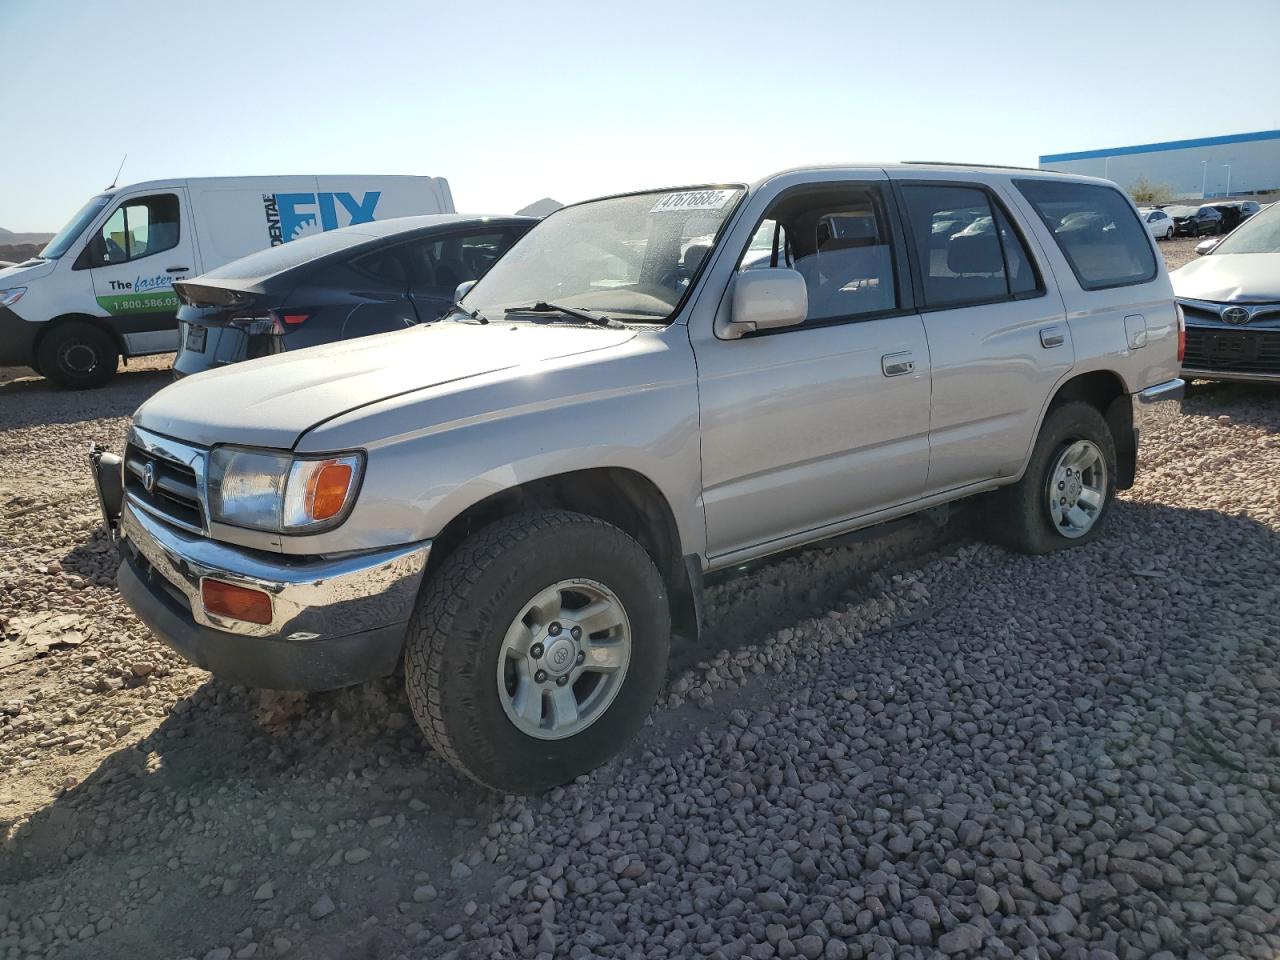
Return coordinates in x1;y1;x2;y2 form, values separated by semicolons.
97;164;1183;791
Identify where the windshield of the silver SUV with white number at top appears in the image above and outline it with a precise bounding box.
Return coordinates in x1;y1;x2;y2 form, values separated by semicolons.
463;187;746;321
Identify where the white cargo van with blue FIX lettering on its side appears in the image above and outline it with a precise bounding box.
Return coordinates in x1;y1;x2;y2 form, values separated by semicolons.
0;175;454;389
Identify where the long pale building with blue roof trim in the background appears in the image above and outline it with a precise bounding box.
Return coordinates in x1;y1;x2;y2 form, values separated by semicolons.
1039;131;1280;198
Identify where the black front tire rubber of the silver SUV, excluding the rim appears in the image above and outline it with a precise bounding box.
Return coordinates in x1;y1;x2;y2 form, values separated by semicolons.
404;511;671;792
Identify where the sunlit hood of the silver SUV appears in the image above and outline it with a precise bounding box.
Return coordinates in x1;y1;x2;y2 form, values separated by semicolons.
133;323;635;449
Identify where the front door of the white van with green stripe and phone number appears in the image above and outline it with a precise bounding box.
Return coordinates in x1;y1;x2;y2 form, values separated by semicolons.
76;188;198;356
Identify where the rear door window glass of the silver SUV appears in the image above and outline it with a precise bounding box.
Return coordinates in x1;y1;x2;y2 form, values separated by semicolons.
902;183;1043;308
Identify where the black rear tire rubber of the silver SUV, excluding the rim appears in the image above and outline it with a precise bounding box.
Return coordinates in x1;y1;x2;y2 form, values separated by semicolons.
987;401;1116;554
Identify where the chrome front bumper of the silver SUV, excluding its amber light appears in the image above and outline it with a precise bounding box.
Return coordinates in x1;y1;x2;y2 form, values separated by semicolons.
116;502;431;690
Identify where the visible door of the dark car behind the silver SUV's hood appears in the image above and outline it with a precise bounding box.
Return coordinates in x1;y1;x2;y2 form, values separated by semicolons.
401;224;524;324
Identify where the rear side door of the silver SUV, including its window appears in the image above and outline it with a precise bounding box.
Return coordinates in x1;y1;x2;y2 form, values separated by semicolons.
893;170;1074;494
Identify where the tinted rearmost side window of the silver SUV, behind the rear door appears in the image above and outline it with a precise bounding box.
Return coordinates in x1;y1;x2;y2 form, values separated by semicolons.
1015;180;1158;291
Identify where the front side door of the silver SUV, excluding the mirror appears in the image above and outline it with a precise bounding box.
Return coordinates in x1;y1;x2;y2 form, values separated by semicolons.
694;180;929;559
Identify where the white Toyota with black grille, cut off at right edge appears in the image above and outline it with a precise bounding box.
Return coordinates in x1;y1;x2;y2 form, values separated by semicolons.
1170;205;1280;384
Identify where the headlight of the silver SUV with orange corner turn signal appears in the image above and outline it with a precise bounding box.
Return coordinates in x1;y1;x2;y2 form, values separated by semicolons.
207;447;365;534
